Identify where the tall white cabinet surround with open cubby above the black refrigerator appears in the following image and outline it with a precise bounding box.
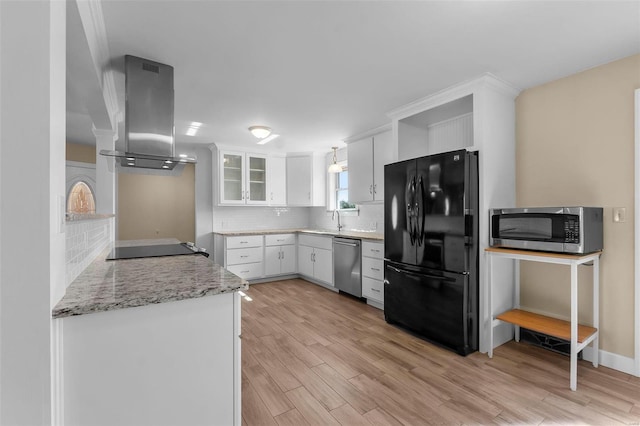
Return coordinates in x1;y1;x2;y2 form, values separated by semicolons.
387;74;519;352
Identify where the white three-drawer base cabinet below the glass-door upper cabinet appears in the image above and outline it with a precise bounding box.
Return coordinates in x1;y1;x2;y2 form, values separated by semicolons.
222;235;264;280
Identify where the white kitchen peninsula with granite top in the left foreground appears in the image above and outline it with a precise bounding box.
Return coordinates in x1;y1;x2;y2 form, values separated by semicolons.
52;240;247;425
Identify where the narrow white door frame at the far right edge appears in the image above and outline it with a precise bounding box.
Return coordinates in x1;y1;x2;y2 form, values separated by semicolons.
633;89;640;377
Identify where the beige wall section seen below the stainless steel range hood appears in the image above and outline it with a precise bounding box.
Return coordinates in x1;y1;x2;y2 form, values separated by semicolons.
116;164;195;242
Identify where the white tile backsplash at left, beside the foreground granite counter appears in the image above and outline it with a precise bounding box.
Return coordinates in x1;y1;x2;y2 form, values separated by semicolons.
65;217;114;286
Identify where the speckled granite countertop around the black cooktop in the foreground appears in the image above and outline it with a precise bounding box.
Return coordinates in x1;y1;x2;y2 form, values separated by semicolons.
52;239;248;318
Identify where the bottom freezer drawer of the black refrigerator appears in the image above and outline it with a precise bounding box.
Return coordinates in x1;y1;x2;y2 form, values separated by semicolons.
384;262;478;355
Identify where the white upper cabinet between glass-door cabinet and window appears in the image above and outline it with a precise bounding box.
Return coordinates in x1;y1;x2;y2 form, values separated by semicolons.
287;154;327;206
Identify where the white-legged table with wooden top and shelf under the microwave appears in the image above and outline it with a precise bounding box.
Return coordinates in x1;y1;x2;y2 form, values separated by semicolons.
485;247;602;390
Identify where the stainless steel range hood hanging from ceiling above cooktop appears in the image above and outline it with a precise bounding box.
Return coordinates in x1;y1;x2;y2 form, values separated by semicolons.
100;55;196;170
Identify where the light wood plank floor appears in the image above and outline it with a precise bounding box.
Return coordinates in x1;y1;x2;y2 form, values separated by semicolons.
242;280;640;425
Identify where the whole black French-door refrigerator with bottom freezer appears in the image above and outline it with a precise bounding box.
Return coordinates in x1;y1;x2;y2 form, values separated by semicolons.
384;150;478;355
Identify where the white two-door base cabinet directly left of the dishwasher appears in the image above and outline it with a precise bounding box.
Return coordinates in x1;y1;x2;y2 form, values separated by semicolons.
298;234;333;287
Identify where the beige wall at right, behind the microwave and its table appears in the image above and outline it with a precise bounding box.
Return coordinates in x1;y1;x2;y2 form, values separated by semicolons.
516;55;640;358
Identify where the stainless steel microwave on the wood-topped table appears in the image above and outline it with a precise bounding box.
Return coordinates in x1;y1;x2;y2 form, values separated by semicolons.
489;207;602;254
